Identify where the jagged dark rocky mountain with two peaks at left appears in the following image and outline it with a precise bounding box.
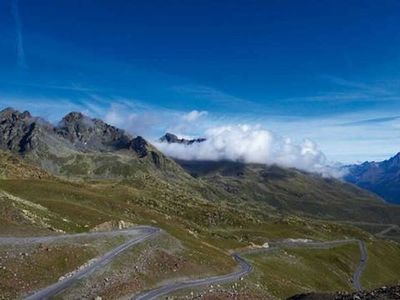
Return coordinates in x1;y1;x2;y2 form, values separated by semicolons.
0;108;186;178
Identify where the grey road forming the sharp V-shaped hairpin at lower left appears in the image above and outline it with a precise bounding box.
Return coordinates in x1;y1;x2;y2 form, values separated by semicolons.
0;226;160;300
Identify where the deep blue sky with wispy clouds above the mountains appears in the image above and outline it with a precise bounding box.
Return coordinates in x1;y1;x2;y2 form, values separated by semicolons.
0;0;400;163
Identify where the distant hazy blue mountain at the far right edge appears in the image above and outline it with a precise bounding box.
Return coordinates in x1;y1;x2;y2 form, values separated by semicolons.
345;153;400;204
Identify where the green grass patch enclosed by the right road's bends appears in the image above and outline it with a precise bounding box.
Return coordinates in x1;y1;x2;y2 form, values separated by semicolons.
246;244;359;299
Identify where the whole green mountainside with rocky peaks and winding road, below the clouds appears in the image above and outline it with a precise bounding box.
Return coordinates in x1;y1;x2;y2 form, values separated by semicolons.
0;109;400;299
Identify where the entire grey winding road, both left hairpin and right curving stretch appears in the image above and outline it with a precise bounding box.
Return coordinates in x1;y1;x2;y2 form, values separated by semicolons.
0;226;368;300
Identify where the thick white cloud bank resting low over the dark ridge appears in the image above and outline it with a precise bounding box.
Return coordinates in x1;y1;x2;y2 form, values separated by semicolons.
155;125;339;177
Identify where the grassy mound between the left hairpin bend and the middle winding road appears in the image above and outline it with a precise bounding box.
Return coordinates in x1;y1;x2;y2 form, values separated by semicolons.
58;234;234;299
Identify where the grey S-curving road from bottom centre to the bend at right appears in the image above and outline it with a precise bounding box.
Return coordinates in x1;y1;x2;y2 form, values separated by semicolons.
130;239;368;300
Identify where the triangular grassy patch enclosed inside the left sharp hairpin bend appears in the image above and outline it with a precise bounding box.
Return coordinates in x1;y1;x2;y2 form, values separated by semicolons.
0;237;125;299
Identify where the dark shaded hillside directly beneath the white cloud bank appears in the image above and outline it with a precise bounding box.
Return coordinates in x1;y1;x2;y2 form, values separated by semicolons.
180;162;400;224
